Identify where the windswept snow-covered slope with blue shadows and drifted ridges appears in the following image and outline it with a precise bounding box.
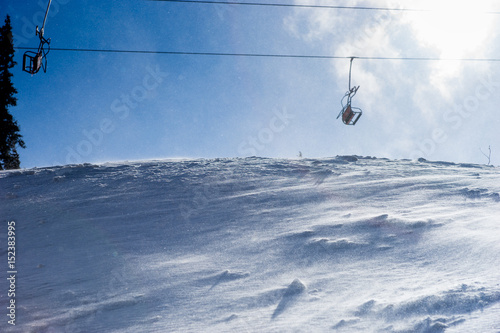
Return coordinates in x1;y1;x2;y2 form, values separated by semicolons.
0;156;500;333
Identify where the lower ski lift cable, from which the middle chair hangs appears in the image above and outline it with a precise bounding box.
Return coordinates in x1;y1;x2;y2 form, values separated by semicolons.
14;47;500;62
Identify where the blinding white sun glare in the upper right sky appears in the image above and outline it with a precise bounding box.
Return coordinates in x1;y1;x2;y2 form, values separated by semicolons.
408;0;495;58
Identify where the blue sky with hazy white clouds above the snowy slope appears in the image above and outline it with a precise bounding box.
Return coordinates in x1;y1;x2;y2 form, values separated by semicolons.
0;0;500;168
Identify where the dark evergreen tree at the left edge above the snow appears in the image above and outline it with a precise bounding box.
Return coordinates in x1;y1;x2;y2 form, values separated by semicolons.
0;15;26;170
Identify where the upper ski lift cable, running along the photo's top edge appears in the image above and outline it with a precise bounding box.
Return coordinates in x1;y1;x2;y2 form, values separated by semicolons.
148;0;500;15
